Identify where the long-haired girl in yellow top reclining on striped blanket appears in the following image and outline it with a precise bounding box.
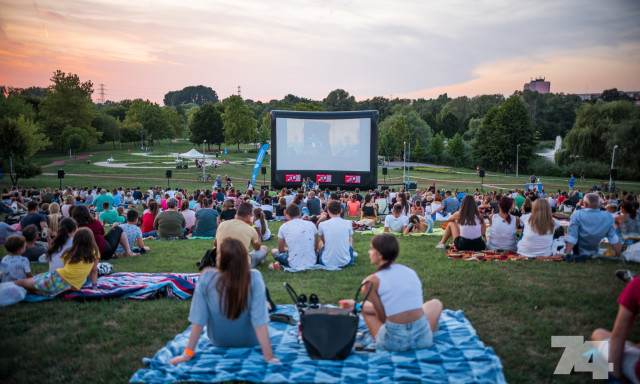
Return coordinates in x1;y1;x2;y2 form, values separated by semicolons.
14;228;100;296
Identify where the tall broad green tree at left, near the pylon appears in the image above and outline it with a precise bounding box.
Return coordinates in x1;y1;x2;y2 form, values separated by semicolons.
40;70;100;151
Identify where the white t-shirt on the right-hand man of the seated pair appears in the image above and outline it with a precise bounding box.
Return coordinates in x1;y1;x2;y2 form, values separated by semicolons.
318;217;353;267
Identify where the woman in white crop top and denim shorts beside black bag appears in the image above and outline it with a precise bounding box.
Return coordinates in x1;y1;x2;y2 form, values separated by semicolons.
342;234;442;352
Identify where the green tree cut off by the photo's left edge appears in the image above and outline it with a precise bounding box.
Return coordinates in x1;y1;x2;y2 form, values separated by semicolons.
0;115;50;185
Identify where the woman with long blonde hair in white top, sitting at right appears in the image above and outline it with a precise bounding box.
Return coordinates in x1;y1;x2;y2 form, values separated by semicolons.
518;199;559;257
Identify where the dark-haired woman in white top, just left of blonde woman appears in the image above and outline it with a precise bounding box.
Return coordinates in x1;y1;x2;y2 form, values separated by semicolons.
487;196;520;251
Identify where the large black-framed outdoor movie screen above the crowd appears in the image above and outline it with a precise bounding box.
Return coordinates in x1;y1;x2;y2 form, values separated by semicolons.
271;111;378;188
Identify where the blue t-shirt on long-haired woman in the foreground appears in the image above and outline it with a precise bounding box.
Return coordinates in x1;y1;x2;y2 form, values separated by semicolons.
189;269;269;348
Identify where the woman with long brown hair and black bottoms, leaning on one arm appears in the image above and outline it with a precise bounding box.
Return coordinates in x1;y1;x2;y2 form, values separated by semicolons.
436;195;487;251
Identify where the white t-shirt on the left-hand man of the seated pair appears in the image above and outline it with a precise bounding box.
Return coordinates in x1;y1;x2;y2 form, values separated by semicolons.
278;219;318;268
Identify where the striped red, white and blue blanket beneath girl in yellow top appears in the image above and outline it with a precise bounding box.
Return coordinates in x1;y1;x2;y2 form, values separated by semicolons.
25;272;200;302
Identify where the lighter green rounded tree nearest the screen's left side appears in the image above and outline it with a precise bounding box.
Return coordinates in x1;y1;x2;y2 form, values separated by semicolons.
222;95;258;152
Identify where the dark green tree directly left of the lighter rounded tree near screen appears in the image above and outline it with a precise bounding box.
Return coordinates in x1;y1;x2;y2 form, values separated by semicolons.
189;103;224;150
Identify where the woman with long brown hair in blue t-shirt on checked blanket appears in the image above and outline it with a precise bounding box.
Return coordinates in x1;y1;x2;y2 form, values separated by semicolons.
169;238;280;365
